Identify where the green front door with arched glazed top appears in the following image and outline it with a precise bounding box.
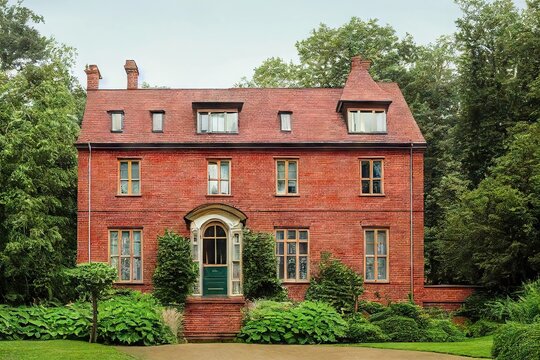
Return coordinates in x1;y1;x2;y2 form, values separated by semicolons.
203;224;227;296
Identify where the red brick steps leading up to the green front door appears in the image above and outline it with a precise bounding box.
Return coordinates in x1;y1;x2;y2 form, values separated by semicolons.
184;297;245;342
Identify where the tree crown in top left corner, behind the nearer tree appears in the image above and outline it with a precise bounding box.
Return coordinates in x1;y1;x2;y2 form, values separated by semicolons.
0;0;52;71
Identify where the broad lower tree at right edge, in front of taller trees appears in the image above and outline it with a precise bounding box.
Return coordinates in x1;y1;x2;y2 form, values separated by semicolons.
439;123;540;290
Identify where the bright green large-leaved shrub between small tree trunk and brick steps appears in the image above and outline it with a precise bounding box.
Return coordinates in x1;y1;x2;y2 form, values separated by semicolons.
98;294;174;345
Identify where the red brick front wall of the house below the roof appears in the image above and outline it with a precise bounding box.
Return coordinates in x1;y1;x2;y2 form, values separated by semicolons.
78;149;424;301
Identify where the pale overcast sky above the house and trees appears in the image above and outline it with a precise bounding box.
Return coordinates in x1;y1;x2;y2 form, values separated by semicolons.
23;0;525;88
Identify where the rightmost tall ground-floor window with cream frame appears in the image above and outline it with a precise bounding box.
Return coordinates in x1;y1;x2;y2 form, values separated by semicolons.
364;229;388;282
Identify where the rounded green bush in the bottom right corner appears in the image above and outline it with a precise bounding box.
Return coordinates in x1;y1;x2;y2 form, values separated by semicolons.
491;323;540;360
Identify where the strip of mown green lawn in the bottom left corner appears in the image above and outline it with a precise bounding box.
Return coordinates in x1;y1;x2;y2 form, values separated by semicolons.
0;340;134;360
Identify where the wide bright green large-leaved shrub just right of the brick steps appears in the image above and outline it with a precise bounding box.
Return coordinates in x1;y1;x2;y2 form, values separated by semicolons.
238;301;347;344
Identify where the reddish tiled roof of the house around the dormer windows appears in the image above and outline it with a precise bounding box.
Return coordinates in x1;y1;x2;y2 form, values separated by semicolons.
77;63;425;145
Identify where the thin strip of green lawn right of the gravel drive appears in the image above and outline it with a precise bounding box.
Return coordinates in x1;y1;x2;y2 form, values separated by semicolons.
351;336;493;358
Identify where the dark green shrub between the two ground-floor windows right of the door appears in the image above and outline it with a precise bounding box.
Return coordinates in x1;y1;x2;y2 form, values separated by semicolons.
306;253;364;313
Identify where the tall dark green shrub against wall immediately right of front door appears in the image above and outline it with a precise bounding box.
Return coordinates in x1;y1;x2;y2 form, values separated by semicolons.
242;229;287;301
